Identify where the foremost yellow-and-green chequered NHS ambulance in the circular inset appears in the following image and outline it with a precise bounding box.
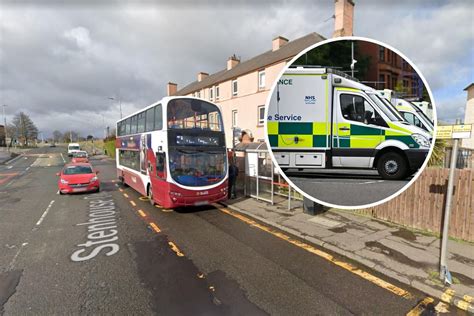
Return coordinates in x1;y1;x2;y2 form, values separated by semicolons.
266;67;432;180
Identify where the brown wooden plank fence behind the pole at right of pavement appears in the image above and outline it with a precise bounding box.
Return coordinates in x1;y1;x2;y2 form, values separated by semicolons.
360;168;474;241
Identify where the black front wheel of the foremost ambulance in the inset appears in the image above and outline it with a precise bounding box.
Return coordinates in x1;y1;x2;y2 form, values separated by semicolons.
374;147;410;180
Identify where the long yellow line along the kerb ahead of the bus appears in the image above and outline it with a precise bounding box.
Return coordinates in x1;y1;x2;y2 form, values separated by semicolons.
215;205;412;299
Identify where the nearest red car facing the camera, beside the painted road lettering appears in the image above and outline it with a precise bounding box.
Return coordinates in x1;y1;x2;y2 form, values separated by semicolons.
56;163;100;194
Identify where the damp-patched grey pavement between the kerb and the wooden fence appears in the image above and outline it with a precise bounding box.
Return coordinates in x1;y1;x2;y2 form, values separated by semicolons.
225;197;474;313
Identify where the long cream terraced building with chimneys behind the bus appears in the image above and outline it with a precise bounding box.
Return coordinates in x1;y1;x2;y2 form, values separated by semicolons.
167;0;354;148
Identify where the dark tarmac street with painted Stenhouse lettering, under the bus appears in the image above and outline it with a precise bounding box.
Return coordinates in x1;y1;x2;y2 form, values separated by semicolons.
0;148;462;315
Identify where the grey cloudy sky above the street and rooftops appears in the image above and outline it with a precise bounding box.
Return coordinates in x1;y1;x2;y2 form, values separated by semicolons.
0;0;474;137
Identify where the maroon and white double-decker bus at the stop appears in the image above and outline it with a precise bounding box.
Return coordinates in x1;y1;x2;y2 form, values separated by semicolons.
116;97;228;208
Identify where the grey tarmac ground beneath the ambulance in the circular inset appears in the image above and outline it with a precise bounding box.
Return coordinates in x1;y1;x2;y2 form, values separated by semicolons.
285;169;411;207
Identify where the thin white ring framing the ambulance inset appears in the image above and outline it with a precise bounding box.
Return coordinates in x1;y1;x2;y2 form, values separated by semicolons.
263;36;438;210
